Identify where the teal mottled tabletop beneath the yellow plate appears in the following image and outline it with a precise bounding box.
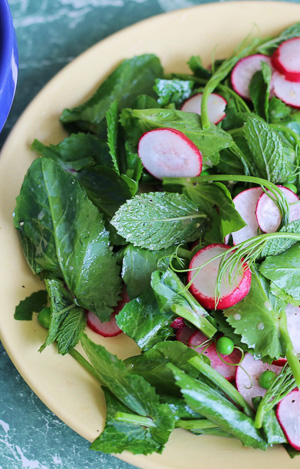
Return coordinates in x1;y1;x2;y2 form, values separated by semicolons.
0;0;299;469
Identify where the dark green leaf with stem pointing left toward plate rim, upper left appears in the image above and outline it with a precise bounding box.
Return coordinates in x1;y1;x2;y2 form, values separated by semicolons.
31;133;113;171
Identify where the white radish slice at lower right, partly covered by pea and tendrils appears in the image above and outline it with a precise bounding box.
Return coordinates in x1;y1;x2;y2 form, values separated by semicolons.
235;353;282;407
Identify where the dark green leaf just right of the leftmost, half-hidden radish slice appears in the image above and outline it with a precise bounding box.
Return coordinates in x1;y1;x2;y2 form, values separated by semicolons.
116;285;174;350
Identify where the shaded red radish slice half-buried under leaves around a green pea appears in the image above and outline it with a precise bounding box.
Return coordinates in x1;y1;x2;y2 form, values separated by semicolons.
189;331;242;381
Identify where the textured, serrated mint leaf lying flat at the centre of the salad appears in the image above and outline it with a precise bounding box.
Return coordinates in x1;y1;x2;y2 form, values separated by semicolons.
111;192;207;251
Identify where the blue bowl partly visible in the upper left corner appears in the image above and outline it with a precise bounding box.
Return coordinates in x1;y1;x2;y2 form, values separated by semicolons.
0;0;18;132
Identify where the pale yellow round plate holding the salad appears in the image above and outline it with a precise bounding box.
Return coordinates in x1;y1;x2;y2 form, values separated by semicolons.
0;2;300;469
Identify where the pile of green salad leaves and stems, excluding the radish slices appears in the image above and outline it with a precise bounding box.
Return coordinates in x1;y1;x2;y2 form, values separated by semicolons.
14;23;300;454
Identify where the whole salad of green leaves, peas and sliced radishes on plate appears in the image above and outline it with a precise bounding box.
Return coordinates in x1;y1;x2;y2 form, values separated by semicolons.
14;23;300;457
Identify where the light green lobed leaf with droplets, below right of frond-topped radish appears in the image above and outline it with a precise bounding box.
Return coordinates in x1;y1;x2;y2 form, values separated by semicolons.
223;270;282;359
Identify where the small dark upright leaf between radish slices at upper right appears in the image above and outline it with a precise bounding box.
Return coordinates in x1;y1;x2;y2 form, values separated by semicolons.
249;61;272;121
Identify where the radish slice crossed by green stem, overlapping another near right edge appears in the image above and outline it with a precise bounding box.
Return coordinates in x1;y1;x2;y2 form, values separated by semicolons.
256;186;299;233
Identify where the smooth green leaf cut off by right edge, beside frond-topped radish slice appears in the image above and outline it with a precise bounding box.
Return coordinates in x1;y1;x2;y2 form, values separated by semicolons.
260;243;300;300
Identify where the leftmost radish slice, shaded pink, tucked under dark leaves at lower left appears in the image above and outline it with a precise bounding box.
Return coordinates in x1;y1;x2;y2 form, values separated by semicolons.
87;289;130;337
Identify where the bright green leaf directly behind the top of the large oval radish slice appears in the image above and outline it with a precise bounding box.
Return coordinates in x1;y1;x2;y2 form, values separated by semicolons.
121;109;233;166
